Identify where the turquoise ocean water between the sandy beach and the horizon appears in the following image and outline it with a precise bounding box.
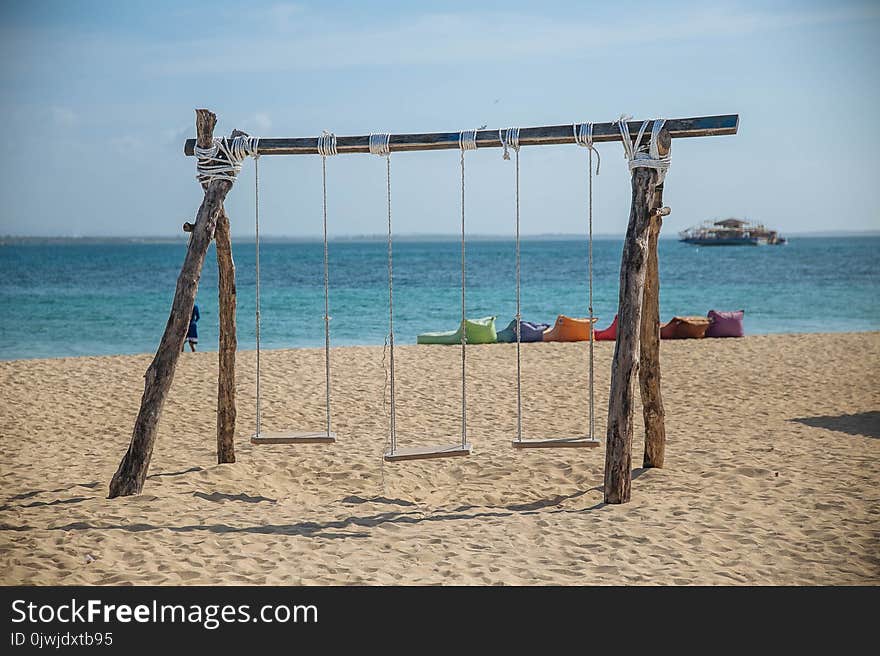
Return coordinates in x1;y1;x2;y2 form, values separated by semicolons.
0;236;880;360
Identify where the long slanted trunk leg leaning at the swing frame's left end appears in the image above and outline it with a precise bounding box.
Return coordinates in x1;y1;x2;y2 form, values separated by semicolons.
109;109;232;499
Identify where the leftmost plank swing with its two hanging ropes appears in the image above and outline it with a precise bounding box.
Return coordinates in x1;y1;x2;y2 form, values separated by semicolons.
251;133;337;452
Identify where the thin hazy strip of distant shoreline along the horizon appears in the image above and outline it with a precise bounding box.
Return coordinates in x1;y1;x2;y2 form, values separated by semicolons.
0;230;880;246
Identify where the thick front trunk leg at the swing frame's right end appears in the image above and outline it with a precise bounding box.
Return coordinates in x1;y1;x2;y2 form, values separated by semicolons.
605;168;658;503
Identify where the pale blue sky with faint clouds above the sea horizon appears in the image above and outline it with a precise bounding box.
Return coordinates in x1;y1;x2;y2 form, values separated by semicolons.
0;0;880;238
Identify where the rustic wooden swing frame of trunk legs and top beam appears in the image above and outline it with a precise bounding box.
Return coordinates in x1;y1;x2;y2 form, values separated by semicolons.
109;109;739;503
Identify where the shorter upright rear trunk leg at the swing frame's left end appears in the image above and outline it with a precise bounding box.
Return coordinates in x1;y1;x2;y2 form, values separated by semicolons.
214;209;238;464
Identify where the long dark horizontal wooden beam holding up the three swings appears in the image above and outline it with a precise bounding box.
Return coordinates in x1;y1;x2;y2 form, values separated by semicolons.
183;114;739;156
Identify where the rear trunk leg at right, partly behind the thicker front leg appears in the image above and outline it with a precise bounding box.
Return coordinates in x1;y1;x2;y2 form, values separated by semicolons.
639;184;666;467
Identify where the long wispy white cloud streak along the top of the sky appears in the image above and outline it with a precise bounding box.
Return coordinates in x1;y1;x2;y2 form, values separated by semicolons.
148;6;880;75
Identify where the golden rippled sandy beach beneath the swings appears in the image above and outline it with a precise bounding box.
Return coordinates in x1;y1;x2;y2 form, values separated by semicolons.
0;333;880;585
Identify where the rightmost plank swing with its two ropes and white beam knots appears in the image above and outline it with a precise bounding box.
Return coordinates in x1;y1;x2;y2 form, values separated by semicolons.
498;123;601;449
